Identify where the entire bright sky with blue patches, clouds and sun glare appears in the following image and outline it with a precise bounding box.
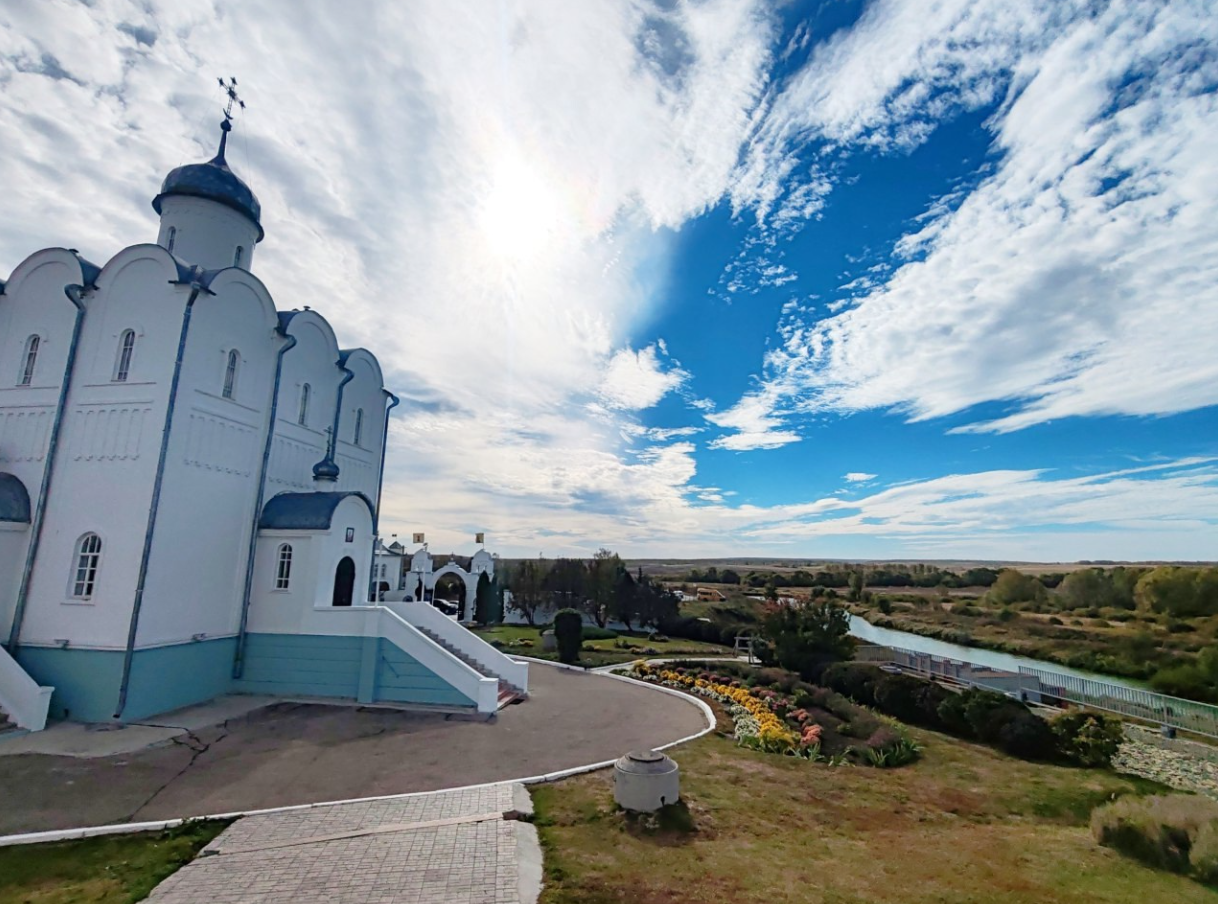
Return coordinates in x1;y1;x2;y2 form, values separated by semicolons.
0;0;1218;561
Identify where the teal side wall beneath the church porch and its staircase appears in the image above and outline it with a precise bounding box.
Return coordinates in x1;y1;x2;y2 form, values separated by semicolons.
233;634;475;708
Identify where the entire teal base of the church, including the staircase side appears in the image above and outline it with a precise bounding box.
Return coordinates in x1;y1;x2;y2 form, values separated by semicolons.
17;634;475;722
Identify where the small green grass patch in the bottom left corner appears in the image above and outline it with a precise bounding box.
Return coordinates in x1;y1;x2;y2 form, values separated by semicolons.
0;820;229;904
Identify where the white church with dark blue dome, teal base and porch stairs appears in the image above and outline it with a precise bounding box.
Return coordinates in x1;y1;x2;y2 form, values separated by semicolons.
0;113;526;730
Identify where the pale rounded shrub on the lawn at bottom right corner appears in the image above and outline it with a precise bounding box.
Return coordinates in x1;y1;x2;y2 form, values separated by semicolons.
1089;794;1216;884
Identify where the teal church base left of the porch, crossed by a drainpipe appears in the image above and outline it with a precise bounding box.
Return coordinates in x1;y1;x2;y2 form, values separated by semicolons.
17;637;237;722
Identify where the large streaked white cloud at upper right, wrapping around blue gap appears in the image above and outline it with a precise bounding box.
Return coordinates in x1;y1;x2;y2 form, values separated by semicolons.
717;2;1218;432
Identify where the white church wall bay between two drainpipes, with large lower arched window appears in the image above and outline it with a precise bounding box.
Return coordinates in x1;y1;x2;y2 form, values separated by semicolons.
10;245;187;649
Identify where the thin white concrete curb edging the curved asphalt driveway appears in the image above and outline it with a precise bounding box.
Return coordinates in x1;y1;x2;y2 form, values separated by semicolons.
0;656;716;848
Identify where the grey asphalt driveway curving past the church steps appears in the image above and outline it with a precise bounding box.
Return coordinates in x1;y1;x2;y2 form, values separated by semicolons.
0;664;705;834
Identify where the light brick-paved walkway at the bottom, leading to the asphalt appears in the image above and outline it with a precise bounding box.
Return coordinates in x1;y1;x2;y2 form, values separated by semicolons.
149;784;540;904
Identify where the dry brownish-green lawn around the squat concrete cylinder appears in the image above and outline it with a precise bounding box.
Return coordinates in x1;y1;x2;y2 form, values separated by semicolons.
533;714;1216;904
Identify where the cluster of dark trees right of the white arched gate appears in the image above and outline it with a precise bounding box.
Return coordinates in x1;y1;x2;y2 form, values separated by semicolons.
503;549;678;630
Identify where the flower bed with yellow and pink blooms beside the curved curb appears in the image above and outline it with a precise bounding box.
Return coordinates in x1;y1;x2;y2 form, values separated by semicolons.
627;661;920;766
